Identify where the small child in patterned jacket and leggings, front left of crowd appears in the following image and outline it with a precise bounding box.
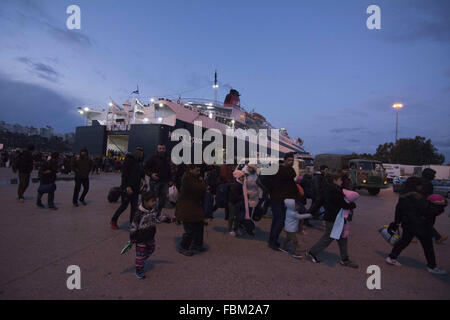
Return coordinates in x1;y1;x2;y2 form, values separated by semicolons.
130;191;157;279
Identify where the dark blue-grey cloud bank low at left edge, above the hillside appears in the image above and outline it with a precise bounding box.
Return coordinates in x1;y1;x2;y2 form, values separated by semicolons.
0;73;83;132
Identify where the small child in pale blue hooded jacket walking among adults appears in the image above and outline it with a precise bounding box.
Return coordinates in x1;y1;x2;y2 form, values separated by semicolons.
278;199;312;259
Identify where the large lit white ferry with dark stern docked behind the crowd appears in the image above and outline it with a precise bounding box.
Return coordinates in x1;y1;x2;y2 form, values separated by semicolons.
74;75;311;165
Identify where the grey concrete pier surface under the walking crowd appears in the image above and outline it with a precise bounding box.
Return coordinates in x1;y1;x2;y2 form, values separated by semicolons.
0;168;450;300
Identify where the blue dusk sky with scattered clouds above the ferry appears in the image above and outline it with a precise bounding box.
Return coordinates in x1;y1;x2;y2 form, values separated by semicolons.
0;0;450;162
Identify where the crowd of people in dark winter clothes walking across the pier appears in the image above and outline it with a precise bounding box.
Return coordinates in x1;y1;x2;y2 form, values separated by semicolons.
6;144;446;279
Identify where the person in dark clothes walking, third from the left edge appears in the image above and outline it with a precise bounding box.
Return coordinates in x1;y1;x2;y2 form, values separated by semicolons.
72;148;94;207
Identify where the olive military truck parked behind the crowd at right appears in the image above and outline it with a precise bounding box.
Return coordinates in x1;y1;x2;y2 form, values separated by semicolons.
314;154;388;196
